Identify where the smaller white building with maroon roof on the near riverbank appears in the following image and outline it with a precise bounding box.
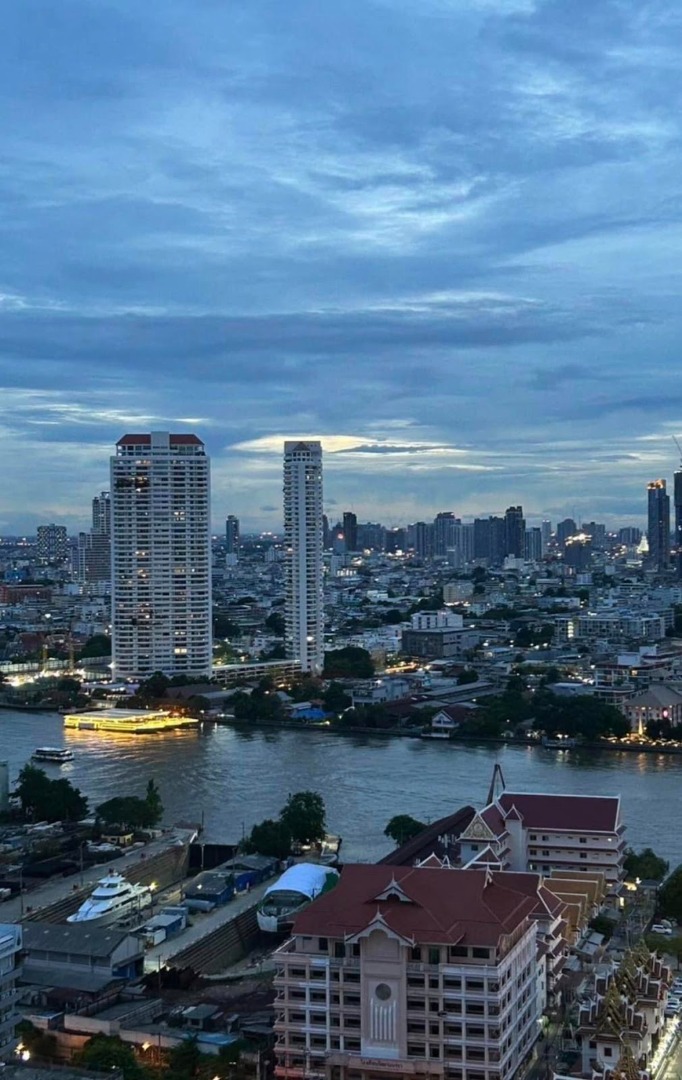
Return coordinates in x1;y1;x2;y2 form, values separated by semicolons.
459;791;626;888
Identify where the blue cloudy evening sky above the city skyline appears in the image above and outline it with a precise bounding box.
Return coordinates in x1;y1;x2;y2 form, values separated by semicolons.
0;0;682;535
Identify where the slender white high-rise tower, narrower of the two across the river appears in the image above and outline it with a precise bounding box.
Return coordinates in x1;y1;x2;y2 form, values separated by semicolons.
284;442;324;672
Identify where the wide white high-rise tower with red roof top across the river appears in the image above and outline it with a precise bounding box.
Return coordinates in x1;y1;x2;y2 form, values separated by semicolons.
111;431;212;678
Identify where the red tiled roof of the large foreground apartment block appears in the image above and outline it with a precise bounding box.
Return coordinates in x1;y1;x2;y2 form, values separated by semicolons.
294;864;537;946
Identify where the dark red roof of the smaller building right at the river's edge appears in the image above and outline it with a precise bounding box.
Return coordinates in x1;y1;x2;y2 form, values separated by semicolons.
492;792;620;833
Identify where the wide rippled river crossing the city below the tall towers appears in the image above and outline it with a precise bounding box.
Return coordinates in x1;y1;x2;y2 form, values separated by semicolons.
0;711;682;865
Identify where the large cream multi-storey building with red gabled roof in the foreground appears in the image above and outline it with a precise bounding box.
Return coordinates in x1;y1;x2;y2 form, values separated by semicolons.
275;864;540;1080
